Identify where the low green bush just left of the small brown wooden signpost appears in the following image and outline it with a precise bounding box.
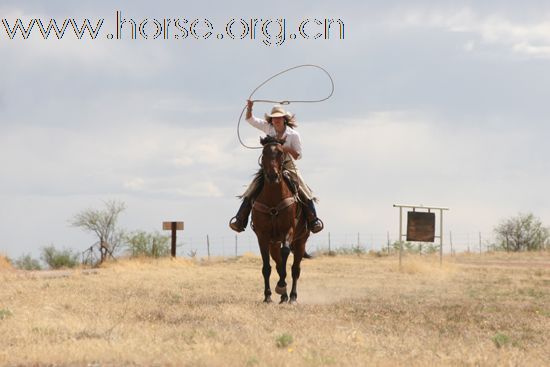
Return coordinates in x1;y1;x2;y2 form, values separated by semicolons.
124;231;170;257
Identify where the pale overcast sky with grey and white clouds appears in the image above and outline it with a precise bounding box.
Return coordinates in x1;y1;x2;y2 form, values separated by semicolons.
0;0;550;258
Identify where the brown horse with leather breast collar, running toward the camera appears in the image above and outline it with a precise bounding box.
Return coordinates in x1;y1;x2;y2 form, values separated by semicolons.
252;136;309;303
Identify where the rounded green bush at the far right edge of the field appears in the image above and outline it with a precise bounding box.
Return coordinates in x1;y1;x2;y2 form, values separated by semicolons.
494;213;550;251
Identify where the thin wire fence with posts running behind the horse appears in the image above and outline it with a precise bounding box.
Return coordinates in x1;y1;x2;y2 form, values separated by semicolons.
177;231;502;257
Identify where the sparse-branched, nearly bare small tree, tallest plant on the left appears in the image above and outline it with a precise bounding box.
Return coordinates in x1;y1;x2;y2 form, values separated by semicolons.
70;200;126;262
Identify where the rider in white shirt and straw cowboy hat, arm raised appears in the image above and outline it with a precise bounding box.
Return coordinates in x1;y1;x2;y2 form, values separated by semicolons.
229;100;323;233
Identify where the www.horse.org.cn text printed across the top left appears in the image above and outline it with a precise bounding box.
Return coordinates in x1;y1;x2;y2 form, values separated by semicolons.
0;10;345;46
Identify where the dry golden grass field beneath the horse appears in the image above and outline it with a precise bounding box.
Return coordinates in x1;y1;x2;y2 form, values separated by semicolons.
0;253;550;366
